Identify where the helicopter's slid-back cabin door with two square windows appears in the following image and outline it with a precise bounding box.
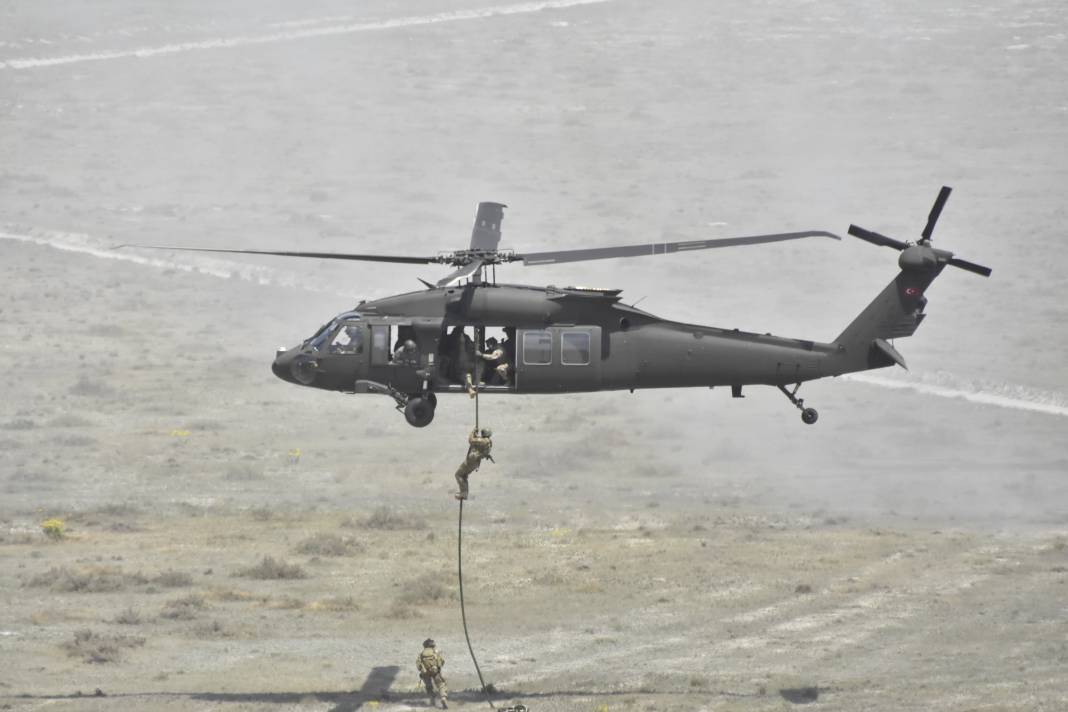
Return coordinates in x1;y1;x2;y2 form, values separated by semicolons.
516;326;601;393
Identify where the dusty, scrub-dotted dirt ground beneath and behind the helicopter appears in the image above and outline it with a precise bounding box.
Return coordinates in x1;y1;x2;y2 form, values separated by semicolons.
0;0;1068;712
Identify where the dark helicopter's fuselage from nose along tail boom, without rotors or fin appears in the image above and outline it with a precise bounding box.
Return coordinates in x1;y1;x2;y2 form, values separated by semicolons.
273;283;837;402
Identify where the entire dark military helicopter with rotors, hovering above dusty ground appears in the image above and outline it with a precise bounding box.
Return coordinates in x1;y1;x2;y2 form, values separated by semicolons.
135;187;991;428
